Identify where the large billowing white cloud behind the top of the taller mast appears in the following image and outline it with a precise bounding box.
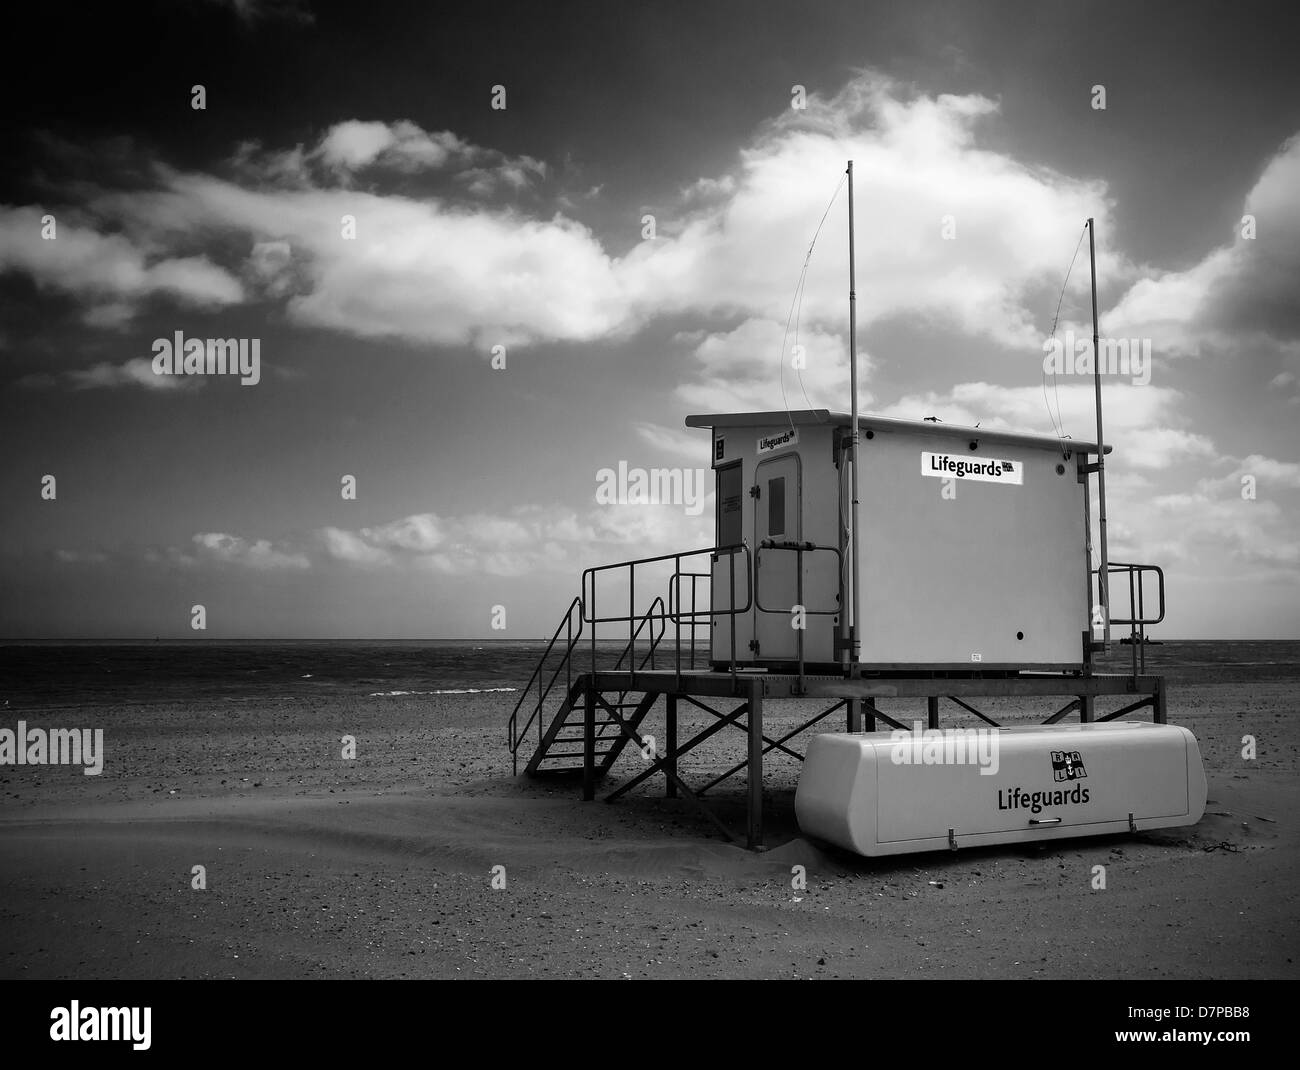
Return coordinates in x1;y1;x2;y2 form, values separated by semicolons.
619;73;1131;346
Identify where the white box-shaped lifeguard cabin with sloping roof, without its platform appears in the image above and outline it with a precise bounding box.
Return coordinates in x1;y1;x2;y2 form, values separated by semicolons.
686;410;1100;671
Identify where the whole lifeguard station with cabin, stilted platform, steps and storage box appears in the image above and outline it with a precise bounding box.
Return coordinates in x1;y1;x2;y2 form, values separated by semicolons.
507;164;1205;855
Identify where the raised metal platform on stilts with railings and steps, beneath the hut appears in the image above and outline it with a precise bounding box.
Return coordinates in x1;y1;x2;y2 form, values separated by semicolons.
507;545;1166;848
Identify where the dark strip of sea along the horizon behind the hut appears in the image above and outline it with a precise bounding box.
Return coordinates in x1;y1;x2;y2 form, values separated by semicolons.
0;640;1300;710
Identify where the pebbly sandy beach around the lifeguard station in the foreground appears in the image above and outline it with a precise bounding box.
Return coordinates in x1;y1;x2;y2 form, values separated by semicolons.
0;657;1300;979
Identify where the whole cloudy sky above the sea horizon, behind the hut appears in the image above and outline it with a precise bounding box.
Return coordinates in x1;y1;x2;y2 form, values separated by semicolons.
0;0;1300;638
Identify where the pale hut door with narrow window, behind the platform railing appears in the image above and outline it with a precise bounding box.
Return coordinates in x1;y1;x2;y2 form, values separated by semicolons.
754;454;803;662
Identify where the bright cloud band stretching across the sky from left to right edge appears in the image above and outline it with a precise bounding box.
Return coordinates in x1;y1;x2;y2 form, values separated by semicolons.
0;72;1300;418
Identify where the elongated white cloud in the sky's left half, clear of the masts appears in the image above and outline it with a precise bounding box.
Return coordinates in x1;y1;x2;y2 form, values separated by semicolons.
96;165;620;347
